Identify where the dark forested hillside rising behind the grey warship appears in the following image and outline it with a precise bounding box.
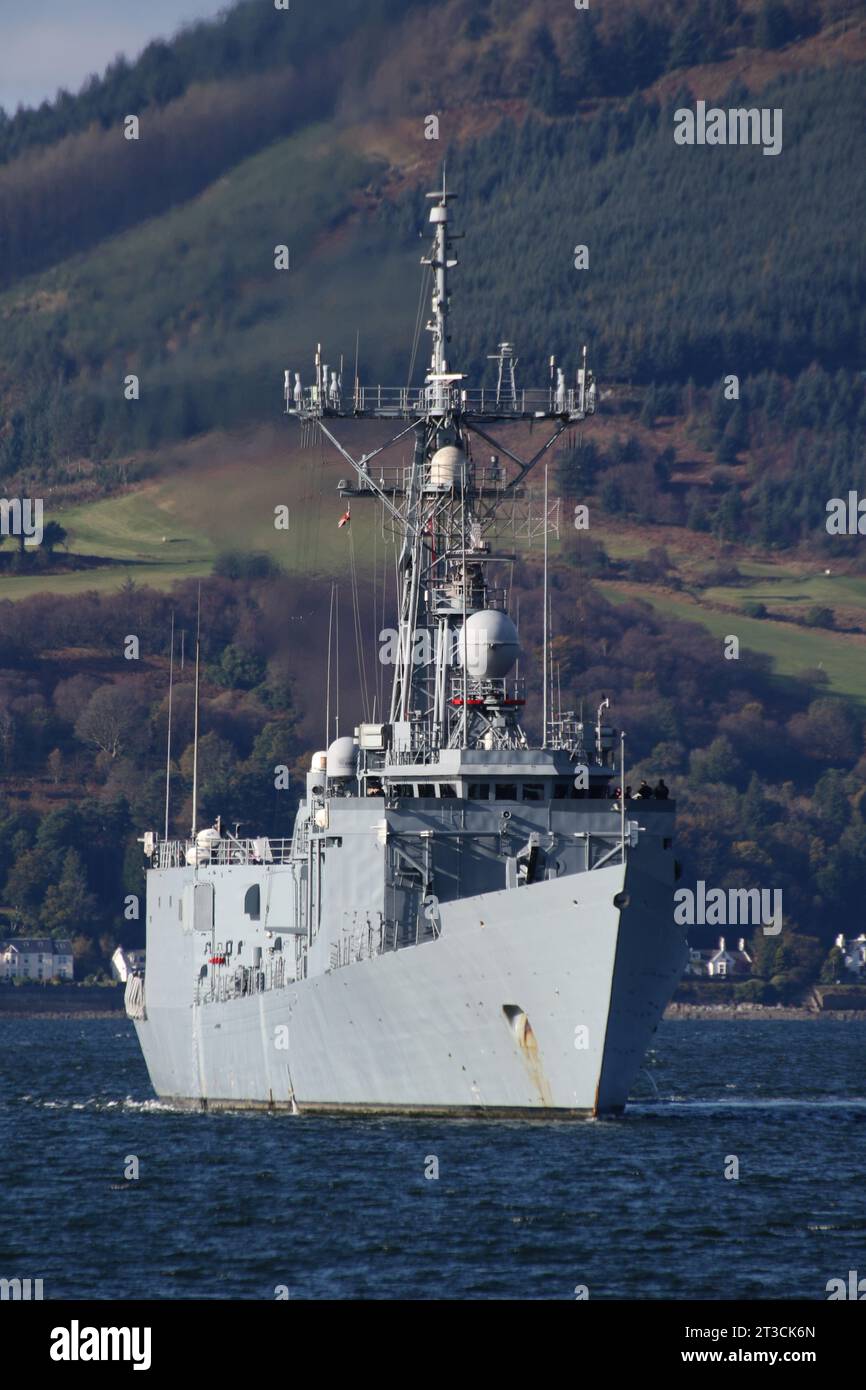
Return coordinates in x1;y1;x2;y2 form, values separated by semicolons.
0;0;866;998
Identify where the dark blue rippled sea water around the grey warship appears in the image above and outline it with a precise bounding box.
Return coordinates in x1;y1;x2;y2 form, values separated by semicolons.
0;1019;866;1300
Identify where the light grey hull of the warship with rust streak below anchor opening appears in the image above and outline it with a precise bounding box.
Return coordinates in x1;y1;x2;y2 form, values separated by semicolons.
136;863;685;1116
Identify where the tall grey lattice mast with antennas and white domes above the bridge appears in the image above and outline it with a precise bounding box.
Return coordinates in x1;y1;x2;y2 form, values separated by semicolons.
285;179;595;752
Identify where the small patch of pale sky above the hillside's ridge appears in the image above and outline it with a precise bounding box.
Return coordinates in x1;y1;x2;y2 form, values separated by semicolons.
0;0;231;113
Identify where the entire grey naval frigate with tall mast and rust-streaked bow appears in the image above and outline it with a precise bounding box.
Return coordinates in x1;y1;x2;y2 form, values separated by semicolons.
126;182;687;1116
